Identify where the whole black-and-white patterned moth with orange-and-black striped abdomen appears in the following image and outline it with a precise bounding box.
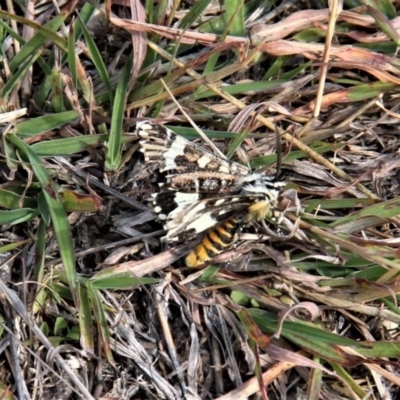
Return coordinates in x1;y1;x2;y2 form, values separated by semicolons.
136;121;286;267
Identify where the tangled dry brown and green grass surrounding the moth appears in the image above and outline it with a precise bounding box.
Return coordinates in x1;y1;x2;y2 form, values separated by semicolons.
0;0;400;400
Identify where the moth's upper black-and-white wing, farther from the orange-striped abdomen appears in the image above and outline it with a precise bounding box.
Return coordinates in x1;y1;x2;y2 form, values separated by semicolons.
136;121;251;223
